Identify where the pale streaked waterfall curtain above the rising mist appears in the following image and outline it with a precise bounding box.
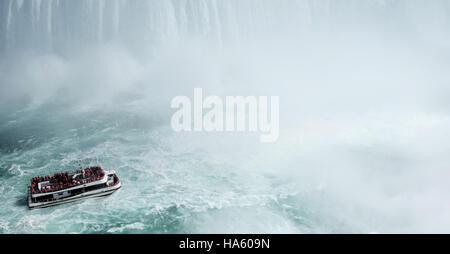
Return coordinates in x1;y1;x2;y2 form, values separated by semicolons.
0;0;450;54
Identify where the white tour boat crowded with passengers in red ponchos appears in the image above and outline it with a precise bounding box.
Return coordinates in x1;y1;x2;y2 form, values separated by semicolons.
28;166;120;209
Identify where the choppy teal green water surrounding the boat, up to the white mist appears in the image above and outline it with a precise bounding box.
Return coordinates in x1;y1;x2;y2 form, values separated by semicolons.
0;99;328;233
